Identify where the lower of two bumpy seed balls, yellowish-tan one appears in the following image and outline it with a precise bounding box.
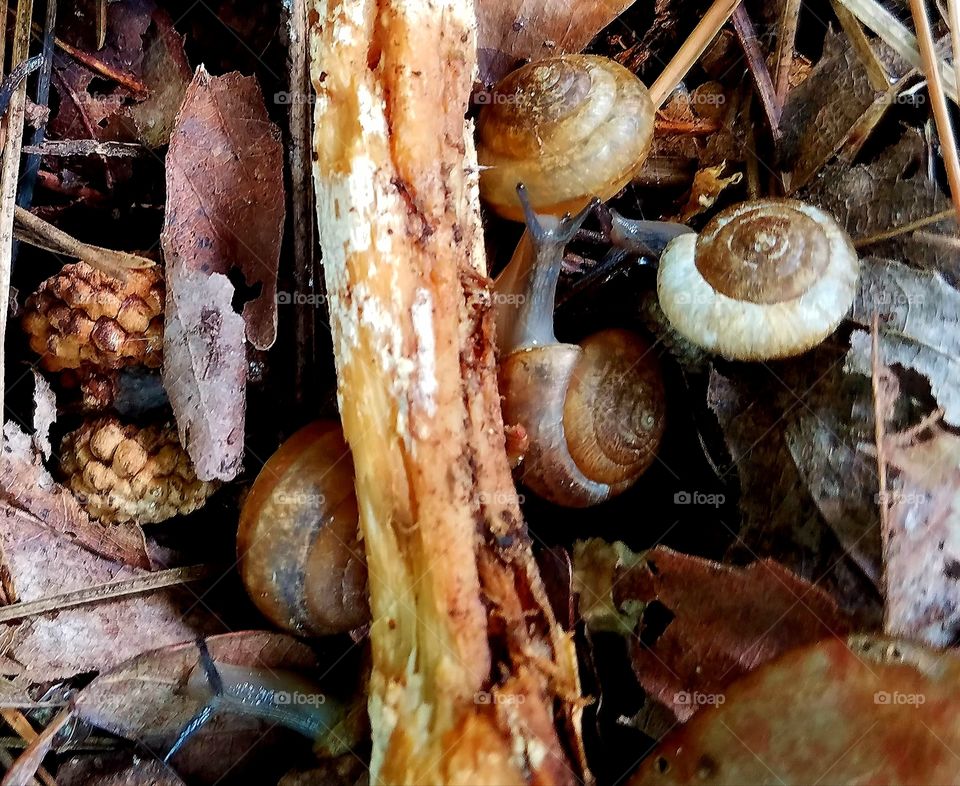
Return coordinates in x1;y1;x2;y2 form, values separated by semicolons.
61;416;216;524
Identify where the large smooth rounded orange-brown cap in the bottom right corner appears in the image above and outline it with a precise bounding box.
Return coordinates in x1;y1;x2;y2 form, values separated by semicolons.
628;637;960;786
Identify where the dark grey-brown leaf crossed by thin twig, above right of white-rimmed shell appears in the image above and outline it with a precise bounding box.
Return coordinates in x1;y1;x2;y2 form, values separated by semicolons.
800;129;960;284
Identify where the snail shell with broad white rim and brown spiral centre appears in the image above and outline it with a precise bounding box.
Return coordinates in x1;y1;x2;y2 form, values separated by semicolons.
657;199;860;360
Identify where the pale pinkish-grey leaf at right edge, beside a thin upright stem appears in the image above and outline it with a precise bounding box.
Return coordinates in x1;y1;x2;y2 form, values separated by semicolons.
883;424;960;647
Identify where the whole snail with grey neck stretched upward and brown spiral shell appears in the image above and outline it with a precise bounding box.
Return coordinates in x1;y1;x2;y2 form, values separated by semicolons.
494;186;666;507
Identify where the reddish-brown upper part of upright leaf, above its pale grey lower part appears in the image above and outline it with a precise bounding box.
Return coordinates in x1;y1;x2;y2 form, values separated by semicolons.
163;67;285;349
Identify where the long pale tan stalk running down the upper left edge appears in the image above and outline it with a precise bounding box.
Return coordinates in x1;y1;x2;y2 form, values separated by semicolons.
0;0;33;454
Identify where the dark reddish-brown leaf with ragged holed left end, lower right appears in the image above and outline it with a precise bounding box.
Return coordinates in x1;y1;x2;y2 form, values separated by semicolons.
577;540;849;721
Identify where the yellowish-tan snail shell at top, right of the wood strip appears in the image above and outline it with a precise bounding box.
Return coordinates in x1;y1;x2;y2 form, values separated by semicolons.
477;55;656;221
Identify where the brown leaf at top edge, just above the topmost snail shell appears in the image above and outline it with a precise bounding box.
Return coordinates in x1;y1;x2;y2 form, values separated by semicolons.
477;0;632;84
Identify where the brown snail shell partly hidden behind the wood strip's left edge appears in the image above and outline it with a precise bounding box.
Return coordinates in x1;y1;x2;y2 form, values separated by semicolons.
237;421;370;635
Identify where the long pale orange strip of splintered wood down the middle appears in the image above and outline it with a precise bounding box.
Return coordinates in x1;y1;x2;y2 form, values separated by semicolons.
311;0;583;784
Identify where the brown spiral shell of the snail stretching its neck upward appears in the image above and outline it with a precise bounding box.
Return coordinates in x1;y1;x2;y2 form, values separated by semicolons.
500;329;666;507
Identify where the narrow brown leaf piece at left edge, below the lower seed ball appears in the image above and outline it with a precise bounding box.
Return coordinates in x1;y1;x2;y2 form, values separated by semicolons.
0;422;150;578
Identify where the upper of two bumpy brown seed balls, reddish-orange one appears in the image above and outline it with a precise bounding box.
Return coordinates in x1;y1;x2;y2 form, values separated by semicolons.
23;262;165;371
